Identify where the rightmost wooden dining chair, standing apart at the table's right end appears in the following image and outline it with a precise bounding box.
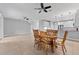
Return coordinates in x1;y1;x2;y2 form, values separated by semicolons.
56;31;68;55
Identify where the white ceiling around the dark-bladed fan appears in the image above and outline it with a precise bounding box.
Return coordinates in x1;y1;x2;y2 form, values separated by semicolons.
0;3;79;20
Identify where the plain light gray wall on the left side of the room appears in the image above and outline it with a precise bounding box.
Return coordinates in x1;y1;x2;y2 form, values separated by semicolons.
4;18;31;36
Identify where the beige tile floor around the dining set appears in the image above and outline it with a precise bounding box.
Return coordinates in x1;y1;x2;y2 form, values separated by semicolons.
0;35;79;55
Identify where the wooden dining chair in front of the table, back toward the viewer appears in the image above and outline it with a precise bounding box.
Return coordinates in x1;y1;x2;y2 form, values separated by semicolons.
39;31;49;54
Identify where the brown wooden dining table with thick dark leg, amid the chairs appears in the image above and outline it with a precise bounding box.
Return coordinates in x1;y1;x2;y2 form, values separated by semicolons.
39;35;57;52
